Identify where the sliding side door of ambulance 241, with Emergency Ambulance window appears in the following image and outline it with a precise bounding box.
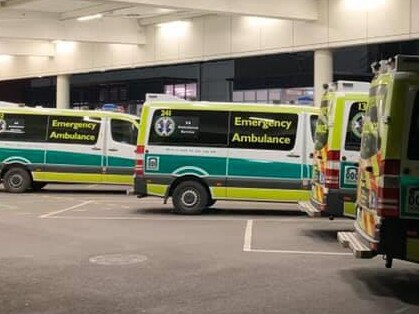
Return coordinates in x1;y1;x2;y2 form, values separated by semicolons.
227;112;304;201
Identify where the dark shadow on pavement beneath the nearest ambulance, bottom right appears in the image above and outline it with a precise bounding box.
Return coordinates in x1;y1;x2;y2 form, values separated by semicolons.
341;261;419;306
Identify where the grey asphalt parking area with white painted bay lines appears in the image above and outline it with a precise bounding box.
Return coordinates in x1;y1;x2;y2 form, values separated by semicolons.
0;185;419;314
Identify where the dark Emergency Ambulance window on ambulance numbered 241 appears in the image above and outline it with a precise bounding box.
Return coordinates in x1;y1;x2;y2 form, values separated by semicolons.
230;112;298;150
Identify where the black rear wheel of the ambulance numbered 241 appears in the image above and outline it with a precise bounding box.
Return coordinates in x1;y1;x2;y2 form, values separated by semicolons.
172;181;209;215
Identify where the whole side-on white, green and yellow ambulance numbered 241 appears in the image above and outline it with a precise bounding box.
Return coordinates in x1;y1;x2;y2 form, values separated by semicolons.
134;101;319;214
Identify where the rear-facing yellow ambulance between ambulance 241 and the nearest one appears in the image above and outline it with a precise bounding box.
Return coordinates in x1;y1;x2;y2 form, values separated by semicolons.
298;81;370;217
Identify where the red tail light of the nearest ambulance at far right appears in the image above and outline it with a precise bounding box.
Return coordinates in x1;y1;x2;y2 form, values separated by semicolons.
377;160;400;217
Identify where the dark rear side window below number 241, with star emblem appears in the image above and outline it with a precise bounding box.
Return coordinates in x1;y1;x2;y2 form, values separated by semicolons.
150;110;228;146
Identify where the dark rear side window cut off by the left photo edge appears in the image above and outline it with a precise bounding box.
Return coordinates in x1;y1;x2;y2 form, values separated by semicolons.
0;113;47;142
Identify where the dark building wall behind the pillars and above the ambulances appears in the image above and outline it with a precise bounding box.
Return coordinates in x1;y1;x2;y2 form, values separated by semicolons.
0;40;419;107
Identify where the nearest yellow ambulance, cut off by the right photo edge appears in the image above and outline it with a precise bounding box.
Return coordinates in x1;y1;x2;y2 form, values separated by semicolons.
338;55;419;267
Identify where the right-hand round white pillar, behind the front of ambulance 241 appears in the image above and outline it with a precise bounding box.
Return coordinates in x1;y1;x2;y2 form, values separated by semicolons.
314;49;333;107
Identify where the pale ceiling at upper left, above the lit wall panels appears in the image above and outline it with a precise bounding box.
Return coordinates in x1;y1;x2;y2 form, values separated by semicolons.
0;0;318;57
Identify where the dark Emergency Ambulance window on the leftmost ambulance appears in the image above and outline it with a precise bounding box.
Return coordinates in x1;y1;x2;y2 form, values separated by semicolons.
47;116;100;145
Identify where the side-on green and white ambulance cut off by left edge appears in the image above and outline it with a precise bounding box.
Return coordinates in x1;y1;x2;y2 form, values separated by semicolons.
0;106;138;193
